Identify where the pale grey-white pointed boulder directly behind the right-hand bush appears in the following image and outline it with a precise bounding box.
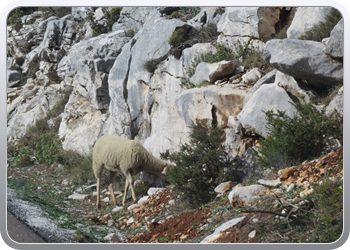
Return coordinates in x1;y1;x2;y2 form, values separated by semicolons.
237;84;296;138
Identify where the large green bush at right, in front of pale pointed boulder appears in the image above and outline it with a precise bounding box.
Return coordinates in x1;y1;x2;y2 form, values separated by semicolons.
253;102;342;169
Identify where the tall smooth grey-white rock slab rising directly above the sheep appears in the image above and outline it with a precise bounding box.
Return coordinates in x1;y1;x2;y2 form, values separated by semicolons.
105;12;183;141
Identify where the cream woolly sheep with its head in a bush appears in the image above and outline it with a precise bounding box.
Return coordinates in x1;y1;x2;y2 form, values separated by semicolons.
92;135;173;209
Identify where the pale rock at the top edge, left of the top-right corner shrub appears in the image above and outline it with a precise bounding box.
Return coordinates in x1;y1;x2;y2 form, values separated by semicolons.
287;7;331;39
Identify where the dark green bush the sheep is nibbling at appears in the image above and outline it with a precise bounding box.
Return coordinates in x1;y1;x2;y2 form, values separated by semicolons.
161;125;232;208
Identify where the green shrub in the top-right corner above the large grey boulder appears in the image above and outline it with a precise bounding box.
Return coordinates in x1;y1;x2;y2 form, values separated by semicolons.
299;8;342;42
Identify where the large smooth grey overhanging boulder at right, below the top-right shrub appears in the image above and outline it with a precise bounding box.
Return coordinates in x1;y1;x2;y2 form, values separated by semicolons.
263;39;343;88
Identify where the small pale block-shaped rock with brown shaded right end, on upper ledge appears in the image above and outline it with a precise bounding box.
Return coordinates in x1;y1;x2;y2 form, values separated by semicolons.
190;61;235;85
